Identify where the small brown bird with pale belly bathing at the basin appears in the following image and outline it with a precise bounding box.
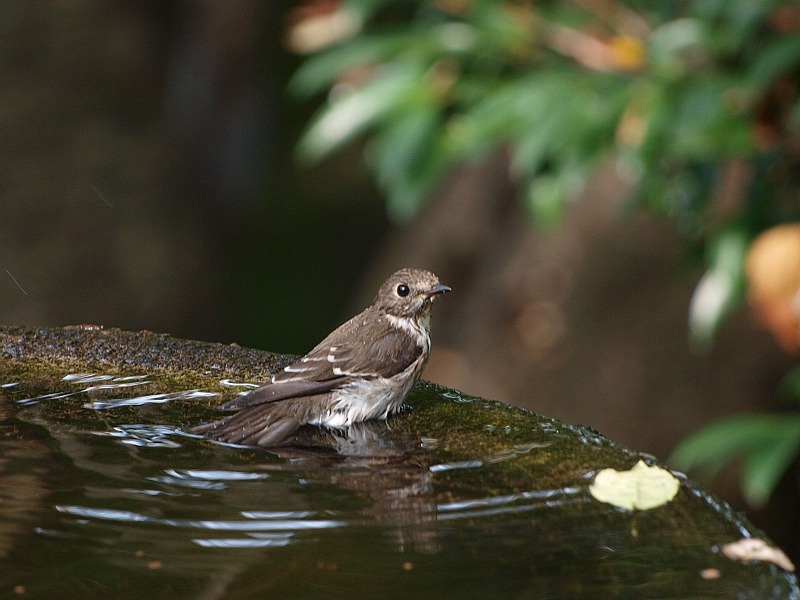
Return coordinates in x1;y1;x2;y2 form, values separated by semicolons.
192;269;450;446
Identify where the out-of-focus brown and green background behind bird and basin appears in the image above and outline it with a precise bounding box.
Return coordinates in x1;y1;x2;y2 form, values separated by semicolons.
0;0;800;557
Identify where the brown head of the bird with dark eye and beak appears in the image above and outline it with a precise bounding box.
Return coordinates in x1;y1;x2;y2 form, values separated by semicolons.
374;269;450;318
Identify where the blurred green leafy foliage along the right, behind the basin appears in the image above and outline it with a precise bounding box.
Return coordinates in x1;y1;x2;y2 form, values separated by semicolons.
288;0;800;502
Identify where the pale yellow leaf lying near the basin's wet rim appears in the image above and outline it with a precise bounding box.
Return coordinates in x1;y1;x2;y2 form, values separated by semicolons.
589;460;681;510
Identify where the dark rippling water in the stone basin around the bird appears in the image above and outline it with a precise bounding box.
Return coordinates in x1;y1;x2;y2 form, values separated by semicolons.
0;372;796;599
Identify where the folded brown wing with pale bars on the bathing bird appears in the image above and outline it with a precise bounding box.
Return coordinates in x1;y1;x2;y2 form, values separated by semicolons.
220;316;423;410
